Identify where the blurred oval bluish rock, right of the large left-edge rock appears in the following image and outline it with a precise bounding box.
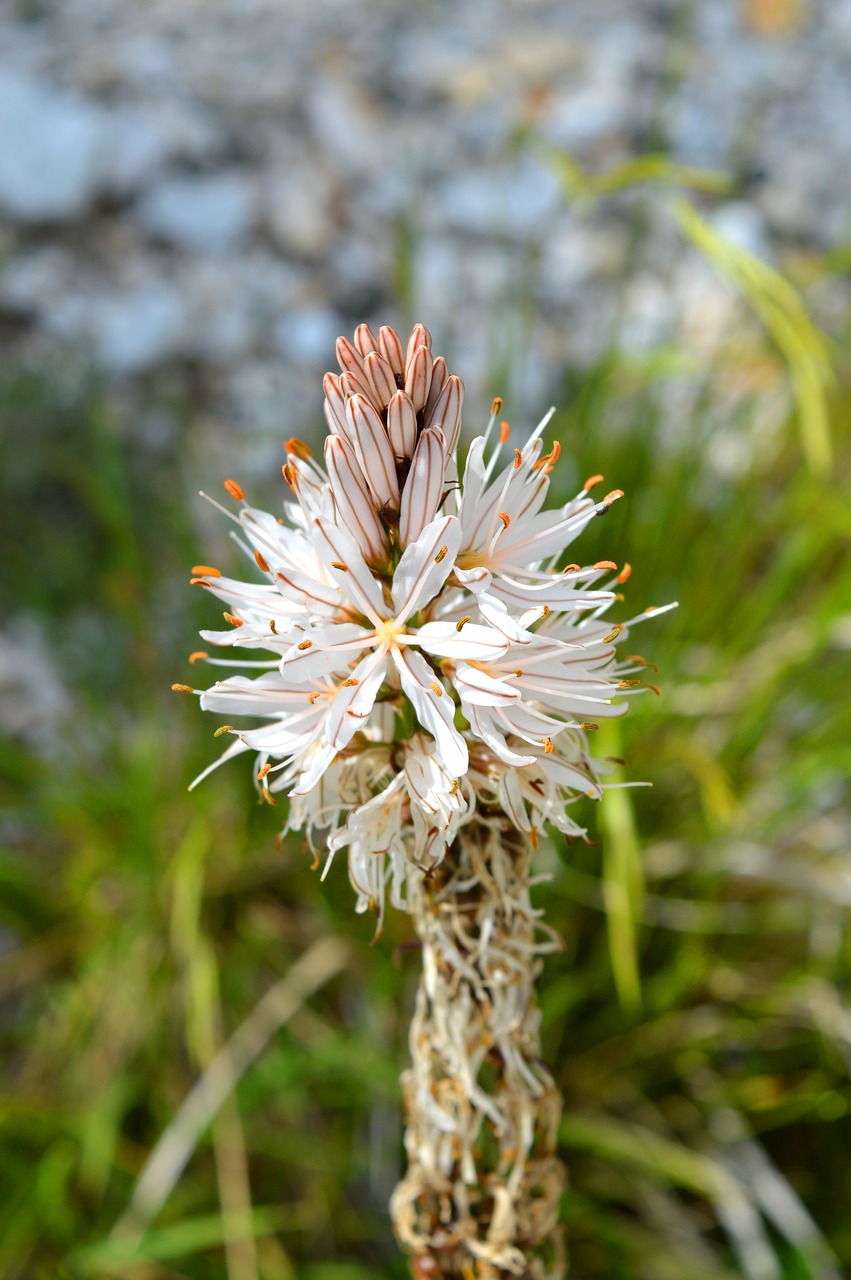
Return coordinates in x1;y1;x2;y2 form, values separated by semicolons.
137;173;256;253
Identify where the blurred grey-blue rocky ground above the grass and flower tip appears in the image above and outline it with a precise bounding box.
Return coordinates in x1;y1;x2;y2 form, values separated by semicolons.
0;0;851;450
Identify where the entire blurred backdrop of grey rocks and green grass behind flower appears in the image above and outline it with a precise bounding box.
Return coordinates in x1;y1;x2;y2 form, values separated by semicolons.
0;0;851;1280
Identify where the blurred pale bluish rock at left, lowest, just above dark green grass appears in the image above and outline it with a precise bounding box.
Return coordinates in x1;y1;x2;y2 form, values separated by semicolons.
95;280;189;374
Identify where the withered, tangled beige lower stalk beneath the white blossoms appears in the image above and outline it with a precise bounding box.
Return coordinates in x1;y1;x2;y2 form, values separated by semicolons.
392;815;566;1280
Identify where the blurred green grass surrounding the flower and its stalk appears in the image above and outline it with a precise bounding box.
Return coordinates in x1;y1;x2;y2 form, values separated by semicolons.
0;202;851;1280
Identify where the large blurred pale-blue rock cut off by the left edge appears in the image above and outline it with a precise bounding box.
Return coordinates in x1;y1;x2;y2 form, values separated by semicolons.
0;72;106;223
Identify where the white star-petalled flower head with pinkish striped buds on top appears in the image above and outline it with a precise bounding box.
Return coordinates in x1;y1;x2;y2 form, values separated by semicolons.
183;325;675;910
